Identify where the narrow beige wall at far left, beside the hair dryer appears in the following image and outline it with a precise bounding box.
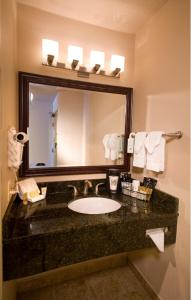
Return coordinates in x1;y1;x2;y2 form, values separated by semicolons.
0;0;17;300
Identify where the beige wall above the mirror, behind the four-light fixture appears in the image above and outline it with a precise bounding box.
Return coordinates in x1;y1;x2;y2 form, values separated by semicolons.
18;5;134;86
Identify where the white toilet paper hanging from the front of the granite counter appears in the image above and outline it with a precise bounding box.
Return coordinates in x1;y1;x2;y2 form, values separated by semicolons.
146;228;165;252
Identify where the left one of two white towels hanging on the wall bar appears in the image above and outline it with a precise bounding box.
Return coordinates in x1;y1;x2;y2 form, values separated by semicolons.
133;131;147;168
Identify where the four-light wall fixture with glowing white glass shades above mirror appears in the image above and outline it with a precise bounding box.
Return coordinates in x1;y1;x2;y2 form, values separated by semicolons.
42;39;125;78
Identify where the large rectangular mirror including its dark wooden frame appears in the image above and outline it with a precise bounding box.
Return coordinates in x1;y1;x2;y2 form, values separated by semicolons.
19;72;133;177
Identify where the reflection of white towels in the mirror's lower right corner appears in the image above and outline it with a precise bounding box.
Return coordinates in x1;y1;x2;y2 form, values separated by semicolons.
103;133;123;161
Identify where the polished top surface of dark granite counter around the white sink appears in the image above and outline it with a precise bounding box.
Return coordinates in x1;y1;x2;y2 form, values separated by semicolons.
4;190;178;240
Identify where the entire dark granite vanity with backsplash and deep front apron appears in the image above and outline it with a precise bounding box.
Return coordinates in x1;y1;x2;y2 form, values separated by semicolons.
3;180;178;280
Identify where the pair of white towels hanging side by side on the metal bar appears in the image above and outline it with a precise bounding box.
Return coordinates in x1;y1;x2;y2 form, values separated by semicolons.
133;131;166;172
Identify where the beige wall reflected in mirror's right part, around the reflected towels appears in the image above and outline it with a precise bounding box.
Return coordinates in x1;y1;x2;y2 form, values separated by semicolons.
89;93;126;165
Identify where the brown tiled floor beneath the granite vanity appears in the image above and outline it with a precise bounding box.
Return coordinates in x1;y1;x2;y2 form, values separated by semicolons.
17;266;153;300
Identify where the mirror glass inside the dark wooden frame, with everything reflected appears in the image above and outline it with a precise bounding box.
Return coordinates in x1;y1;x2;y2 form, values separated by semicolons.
28;83;126;168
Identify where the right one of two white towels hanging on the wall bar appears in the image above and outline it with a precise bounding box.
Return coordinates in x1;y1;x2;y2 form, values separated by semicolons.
145;131;166;172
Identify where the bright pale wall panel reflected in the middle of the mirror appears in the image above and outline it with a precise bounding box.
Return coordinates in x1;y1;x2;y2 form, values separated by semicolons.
57;90;83;166
